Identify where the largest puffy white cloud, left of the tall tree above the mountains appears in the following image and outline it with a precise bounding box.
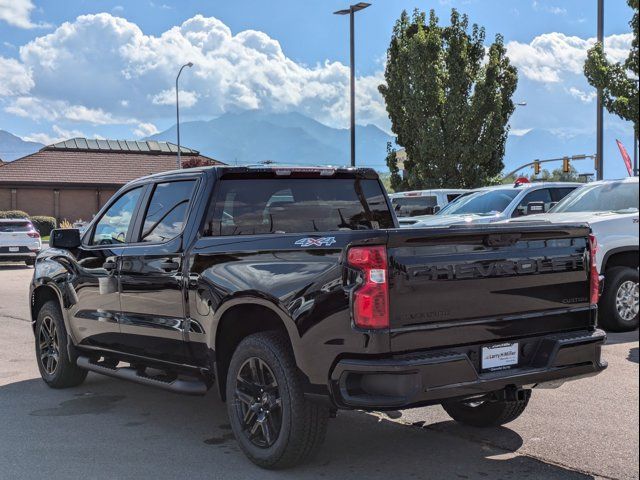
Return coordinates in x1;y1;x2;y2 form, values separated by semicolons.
8;13;388;128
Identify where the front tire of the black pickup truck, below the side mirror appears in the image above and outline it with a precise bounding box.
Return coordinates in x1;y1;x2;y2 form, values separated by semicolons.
35;301;88;388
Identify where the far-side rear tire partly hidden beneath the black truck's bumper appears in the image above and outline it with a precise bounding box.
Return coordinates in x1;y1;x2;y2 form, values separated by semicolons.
442;394;530;428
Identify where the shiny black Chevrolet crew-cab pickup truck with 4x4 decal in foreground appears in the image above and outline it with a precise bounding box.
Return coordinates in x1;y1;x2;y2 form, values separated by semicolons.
30;167;606;468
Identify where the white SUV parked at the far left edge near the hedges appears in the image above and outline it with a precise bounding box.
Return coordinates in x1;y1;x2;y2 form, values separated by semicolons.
0;218;42;265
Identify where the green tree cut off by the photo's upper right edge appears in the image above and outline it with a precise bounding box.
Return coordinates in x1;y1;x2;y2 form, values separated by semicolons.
584;0;640;134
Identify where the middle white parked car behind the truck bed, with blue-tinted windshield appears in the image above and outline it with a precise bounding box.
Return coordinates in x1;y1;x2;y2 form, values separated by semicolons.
399;182;581;227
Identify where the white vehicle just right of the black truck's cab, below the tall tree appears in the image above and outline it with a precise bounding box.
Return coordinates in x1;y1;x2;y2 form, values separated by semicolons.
389;188;468;225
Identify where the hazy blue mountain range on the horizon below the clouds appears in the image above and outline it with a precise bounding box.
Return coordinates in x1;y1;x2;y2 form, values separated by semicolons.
0;110;633;178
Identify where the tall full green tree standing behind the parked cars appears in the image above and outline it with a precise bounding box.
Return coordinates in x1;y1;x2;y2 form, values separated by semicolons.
379;9;518;190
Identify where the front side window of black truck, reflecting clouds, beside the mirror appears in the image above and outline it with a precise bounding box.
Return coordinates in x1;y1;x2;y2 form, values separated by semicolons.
89;187;142;245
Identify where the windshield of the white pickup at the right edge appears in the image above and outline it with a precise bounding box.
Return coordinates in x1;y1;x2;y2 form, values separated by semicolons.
550;182;638;213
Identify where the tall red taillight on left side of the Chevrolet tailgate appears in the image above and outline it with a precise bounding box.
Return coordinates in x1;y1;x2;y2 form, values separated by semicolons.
348;246;389;329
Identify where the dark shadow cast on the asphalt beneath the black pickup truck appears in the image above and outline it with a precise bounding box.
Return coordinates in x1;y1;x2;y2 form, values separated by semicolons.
0;374;593;480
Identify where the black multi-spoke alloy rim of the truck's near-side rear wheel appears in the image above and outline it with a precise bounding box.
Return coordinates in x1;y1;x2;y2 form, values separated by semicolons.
235;357;282;448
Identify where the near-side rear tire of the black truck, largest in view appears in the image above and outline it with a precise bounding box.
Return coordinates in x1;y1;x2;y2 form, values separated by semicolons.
226;332;329;469
